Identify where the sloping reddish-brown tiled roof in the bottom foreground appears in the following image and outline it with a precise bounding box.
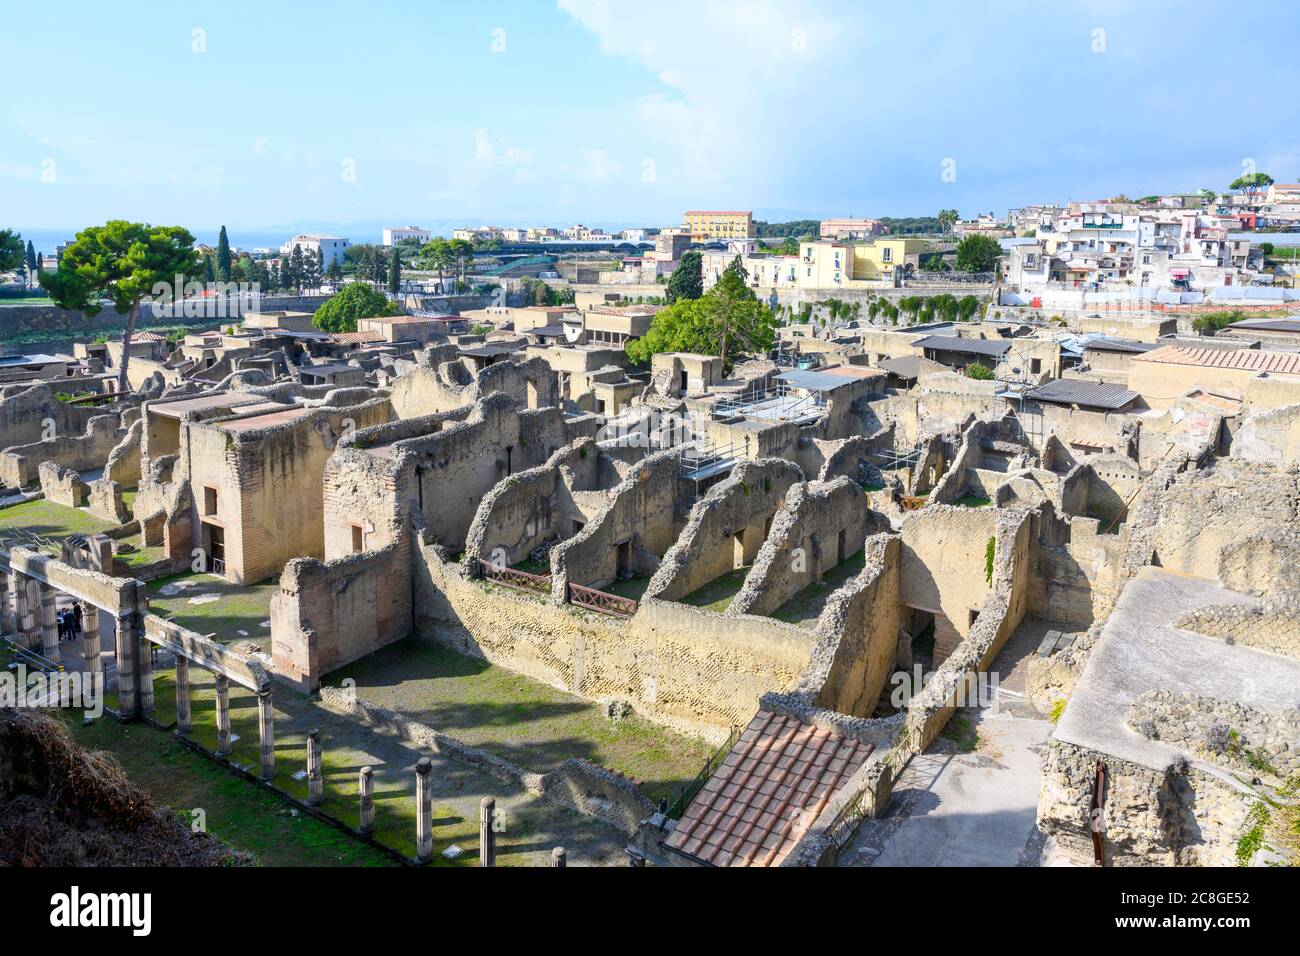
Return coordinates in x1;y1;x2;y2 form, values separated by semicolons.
664;710;874;866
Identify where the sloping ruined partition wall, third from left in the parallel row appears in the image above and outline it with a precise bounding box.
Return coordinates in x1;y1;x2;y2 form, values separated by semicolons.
646;458;802;601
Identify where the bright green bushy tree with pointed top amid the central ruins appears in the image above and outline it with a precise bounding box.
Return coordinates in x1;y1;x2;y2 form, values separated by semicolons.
624;256;776;371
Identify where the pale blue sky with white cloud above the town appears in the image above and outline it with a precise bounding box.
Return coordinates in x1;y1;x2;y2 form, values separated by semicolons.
0;0;1300;230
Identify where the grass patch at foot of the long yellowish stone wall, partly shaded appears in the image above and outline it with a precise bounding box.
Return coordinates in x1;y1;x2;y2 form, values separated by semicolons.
325;637;714;800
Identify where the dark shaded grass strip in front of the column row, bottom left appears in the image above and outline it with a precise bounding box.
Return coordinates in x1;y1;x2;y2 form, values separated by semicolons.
57;714;393;866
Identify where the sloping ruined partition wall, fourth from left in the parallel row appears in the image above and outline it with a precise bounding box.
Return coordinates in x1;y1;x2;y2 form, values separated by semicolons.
727;477;871;615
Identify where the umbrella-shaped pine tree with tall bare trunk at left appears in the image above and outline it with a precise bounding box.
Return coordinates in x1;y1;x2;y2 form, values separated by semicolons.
40;220;200;393
